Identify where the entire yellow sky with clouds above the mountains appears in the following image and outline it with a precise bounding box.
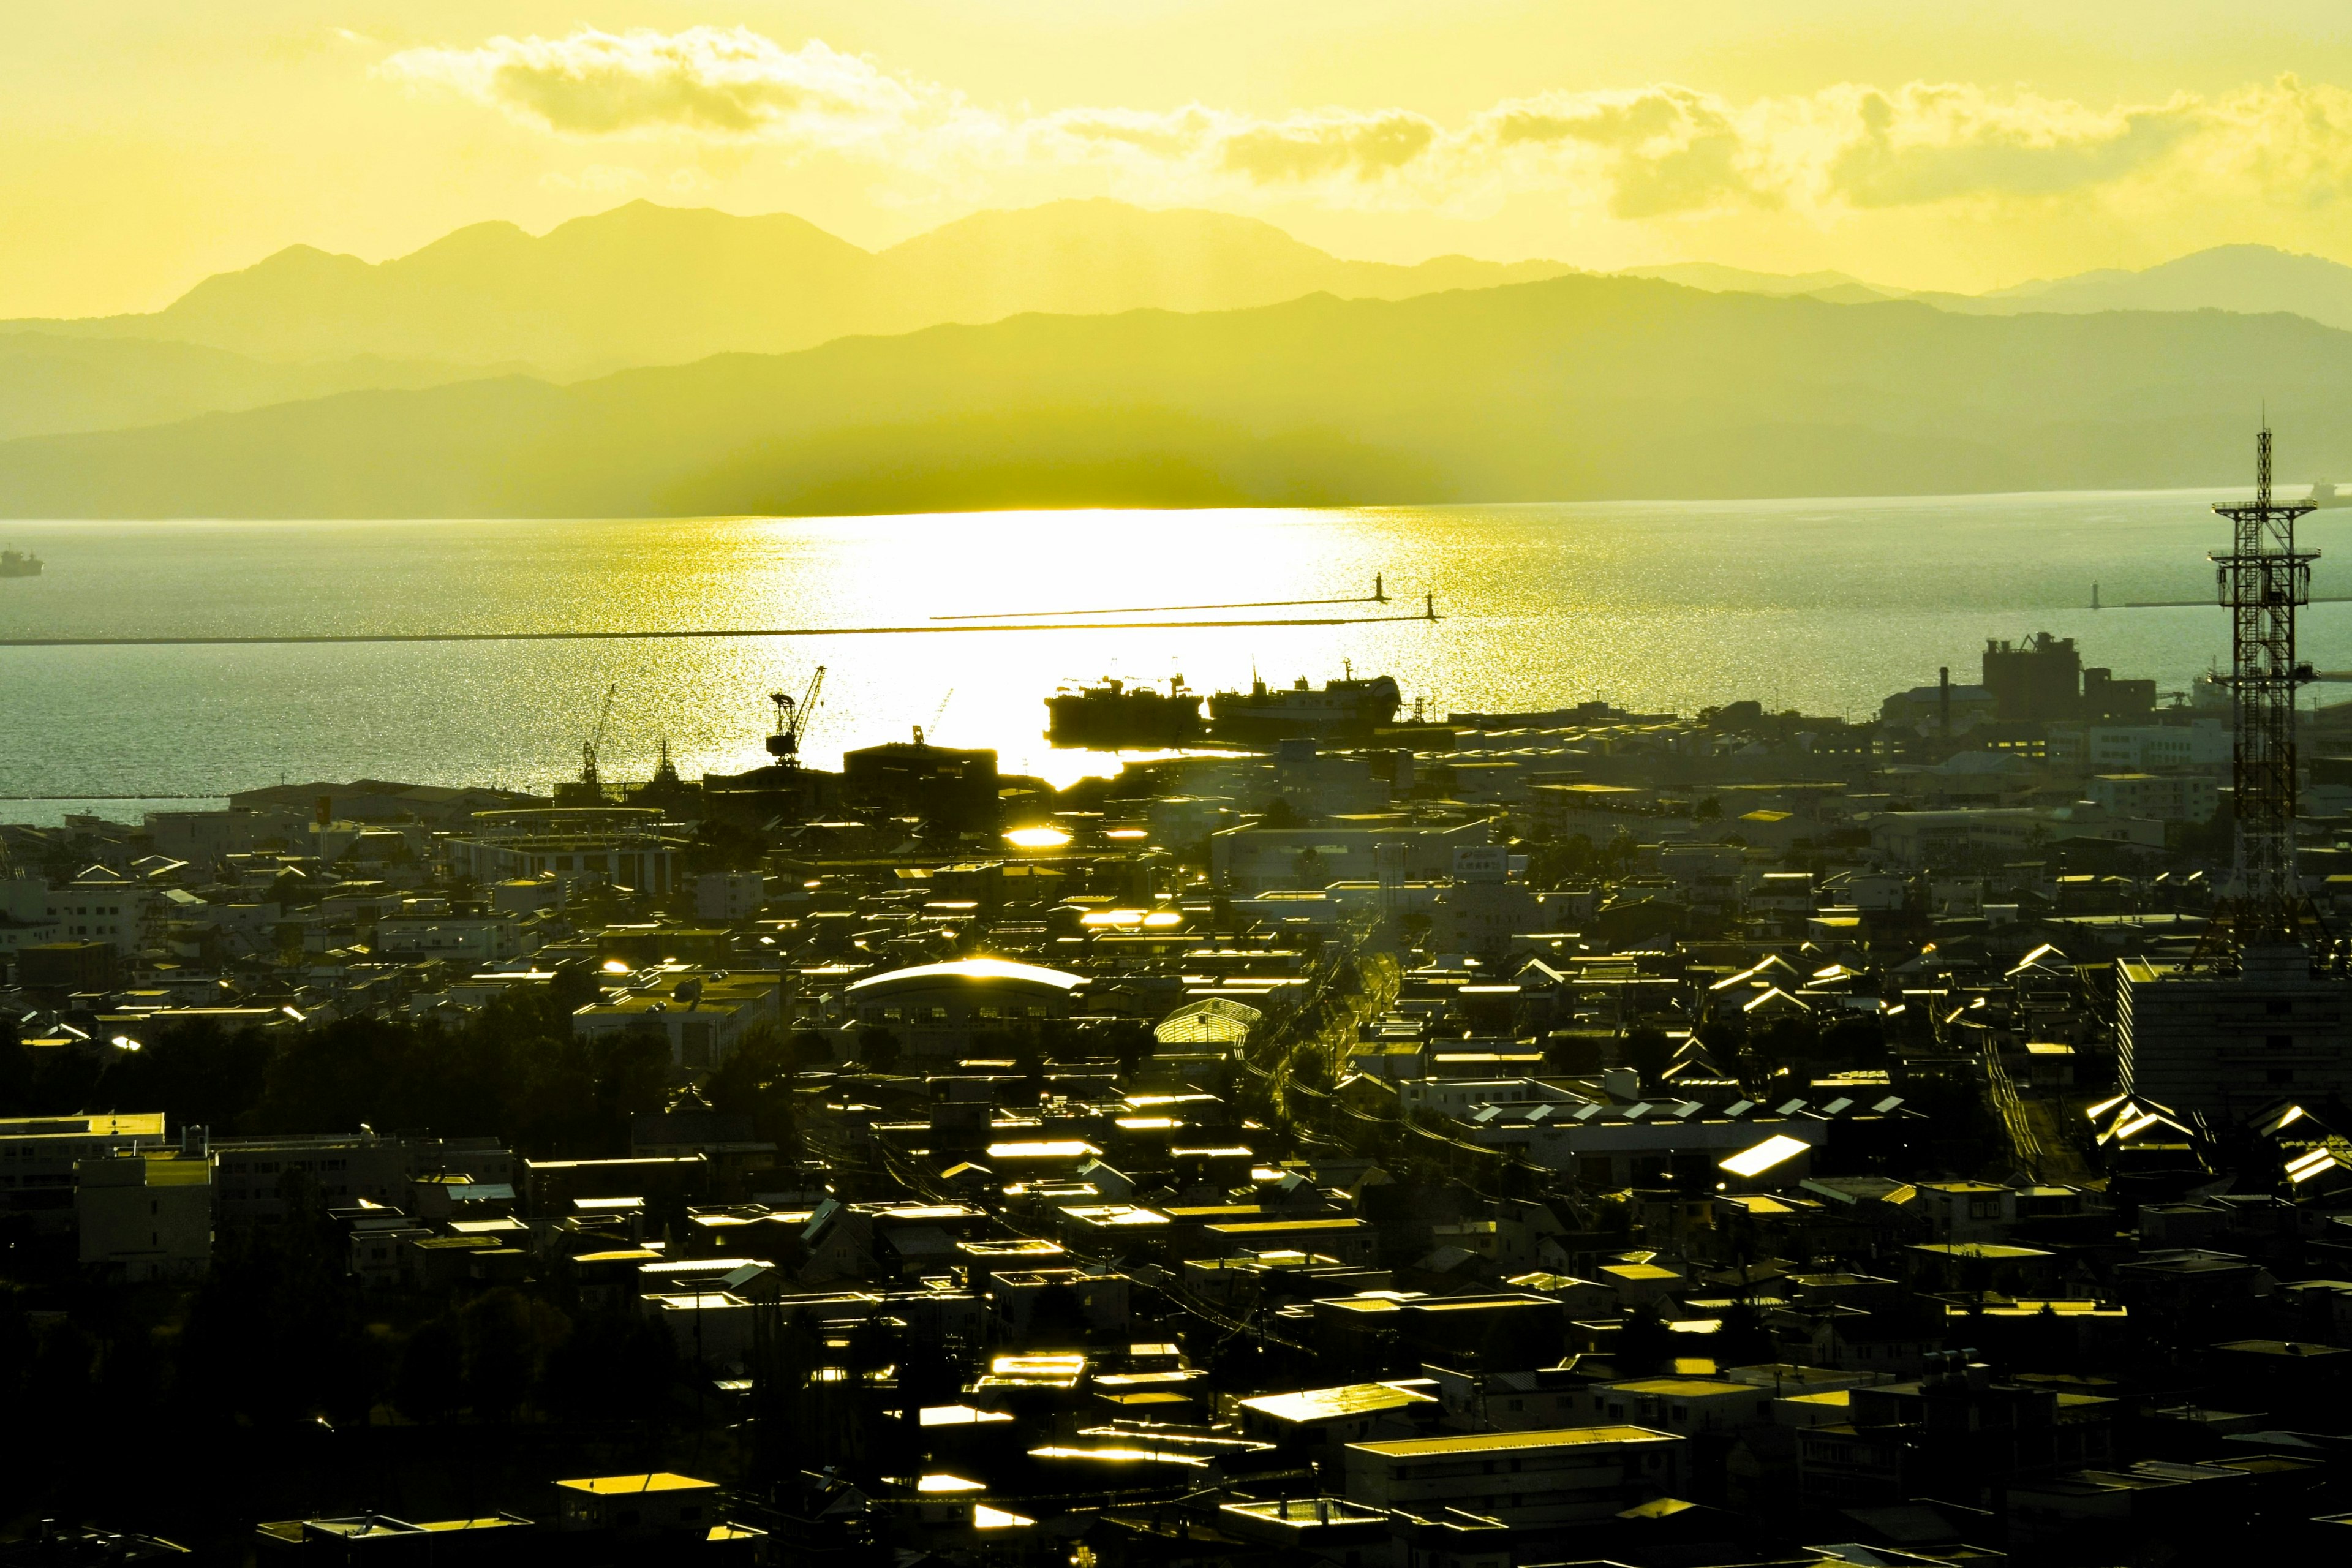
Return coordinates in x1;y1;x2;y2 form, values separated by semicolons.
13;0;2352;317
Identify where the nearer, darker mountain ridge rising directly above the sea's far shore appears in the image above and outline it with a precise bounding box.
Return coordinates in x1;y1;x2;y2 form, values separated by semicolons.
0;275;2352;517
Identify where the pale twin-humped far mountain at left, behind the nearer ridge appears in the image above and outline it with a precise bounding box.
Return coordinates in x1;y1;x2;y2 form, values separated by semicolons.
19;200;1571;376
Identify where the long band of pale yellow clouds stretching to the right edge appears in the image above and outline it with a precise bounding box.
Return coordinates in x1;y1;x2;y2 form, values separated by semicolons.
376;26;2352;224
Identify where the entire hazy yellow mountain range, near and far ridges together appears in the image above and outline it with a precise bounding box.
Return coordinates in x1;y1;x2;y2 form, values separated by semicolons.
13;202;2352;517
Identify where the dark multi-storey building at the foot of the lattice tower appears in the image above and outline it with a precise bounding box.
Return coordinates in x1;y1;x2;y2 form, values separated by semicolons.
2114;948;2352;1114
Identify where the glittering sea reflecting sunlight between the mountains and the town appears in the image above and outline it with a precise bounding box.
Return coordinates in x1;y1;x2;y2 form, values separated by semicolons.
0;491;2323;823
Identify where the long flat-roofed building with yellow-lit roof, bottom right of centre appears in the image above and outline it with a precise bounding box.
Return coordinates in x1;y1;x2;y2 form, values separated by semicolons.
1345;1425;1684;1526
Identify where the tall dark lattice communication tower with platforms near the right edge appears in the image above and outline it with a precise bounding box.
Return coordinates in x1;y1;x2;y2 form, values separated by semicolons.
2211;423;2319;952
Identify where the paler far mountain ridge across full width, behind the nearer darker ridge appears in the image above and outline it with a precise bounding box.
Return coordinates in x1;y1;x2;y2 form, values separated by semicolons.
13;200;2352;461
